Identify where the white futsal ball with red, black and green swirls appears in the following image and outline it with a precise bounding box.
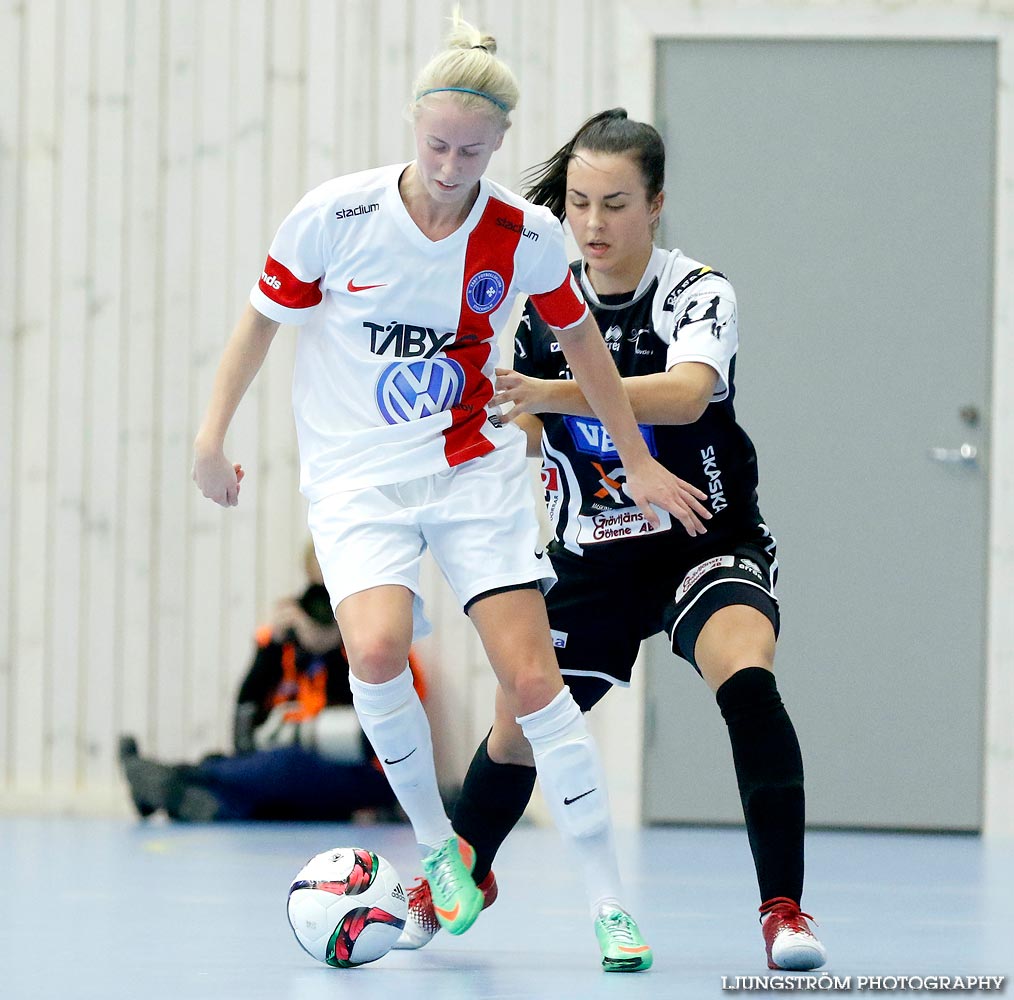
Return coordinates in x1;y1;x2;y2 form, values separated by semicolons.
287;847;409;969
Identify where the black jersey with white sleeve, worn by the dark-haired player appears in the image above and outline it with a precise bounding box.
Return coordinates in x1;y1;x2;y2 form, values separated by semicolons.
514;248;767;565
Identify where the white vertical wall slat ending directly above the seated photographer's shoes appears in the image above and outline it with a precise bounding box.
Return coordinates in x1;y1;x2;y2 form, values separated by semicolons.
117;0;164;749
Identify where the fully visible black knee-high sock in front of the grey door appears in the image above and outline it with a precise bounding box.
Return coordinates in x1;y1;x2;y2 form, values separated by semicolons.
715;666;805;903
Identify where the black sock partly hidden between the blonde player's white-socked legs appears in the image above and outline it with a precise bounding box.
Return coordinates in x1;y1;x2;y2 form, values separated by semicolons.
452;736;535;883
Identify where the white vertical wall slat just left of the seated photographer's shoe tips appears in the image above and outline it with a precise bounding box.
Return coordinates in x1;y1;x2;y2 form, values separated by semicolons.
82;0;129;784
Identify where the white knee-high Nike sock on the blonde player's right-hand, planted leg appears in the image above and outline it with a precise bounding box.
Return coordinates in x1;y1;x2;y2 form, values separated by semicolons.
517;688;623;916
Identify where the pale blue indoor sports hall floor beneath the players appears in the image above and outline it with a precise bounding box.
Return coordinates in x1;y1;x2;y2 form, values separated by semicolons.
0;817;1014;1000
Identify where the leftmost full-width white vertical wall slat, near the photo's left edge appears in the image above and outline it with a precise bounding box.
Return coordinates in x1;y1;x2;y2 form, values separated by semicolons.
11;0;59;790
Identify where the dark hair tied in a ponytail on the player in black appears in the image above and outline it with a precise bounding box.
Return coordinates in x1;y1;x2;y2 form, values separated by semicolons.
522;108;665;220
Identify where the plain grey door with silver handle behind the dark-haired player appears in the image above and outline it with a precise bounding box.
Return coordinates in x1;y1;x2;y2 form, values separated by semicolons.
644;40;997;830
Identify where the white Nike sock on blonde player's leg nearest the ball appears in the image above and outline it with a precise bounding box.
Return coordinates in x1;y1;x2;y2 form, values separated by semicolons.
349;667;453;854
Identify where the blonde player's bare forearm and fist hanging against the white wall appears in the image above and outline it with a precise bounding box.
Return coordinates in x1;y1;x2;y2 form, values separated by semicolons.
193;305;279;507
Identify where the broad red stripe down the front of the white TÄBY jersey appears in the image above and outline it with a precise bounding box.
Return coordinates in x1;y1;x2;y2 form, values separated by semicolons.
444;198;524;466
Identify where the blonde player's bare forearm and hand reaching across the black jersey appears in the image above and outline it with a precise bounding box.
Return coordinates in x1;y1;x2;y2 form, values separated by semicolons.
557;312;711;537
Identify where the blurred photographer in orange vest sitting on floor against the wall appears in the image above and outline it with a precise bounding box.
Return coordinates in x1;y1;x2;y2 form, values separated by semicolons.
120;545;407;822
